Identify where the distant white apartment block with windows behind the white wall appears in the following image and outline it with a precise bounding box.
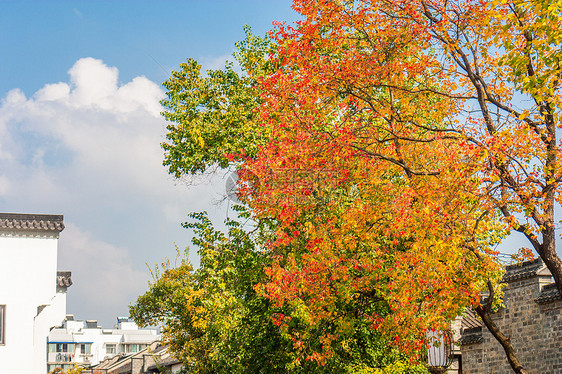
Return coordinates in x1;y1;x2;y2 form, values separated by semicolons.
47;315;160;371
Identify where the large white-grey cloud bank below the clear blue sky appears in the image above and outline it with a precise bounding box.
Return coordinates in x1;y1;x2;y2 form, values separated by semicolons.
0;58;224;328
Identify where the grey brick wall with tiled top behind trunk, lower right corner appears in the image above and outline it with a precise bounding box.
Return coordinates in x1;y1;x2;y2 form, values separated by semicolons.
461;260;562;374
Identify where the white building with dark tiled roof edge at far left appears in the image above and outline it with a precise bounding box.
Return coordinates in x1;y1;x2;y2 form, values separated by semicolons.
0;213;72;374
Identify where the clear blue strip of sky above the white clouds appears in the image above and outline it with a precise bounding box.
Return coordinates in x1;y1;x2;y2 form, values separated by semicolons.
0;0;296;98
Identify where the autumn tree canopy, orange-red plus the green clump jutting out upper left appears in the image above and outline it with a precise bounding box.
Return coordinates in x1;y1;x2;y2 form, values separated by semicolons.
154;0;561;373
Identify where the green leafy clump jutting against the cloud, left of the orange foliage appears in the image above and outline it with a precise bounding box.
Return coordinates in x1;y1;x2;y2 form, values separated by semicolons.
161;26;274;178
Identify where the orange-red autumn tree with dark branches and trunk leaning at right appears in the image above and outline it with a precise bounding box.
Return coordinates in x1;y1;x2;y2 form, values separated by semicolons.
232;0;562;373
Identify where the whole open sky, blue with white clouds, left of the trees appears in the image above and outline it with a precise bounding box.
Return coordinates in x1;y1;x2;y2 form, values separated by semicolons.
0;0;297;327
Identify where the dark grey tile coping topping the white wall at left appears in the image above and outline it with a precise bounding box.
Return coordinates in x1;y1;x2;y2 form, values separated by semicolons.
0;213;64;232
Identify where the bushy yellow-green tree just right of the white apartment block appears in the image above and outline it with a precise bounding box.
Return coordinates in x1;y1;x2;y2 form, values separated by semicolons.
130;214;290;373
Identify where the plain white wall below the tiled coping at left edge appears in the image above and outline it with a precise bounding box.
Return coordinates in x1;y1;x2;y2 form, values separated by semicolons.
0;233;66;374
